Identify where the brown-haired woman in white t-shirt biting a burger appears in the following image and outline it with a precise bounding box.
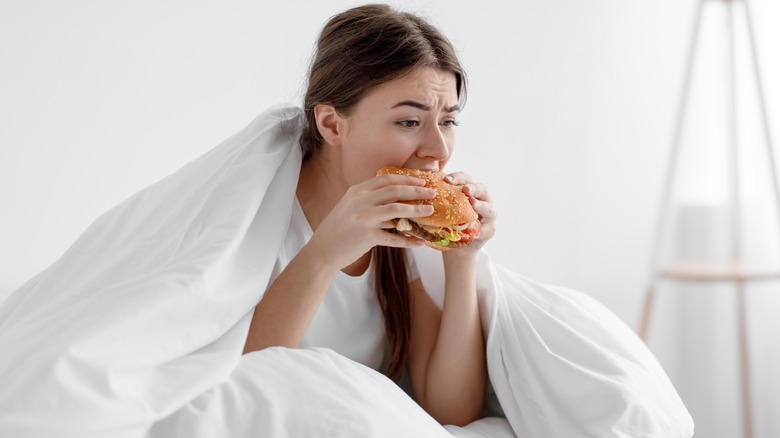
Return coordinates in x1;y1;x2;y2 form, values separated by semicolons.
245;5;495;425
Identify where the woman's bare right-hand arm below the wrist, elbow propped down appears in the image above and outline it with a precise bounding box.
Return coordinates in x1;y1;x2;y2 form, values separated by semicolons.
408;254;487;426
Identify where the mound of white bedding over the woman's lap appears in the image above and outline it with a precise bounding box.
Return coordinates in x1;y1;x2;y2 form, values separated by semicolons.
149;348;514;438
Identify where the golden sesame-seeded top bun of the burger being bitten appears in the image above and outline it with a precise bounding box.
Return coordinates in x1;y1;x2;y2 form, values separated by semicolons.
376;167;478;227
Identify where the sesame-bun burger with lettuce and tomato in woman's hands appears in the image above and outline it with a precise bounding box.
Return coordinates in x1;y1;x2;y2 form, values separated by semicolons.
377;167;481;251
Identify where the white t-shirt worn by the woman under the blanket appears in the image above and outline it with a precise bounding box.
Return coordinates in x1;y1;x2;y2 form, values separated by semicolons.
271;197;419;370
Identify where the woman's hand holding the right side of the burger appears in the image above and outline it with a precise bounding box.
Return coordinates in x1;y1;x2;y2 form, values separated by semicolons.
444;172;496;256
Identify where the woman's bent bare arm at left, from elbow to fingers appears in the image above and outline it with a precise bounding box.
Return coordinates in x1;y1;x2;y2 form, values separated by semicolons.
244;175;435;353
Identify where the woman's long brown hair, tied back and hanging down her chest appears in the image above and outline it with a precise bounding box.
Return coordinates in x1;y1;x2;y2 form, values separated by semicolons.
300;5;466;380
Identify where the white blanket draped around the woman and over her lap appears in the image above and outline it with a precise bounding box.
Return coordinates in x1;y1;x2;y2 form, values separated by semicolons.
0;107;693;438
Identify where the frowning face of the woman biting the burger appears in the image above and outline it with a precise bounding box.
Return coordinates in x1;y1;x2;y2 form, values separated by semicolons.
341;67;459;185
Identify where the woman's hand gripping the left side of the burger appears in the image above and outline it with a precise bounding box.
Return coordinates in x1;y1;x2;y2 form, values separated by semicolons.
309;175;436;270
